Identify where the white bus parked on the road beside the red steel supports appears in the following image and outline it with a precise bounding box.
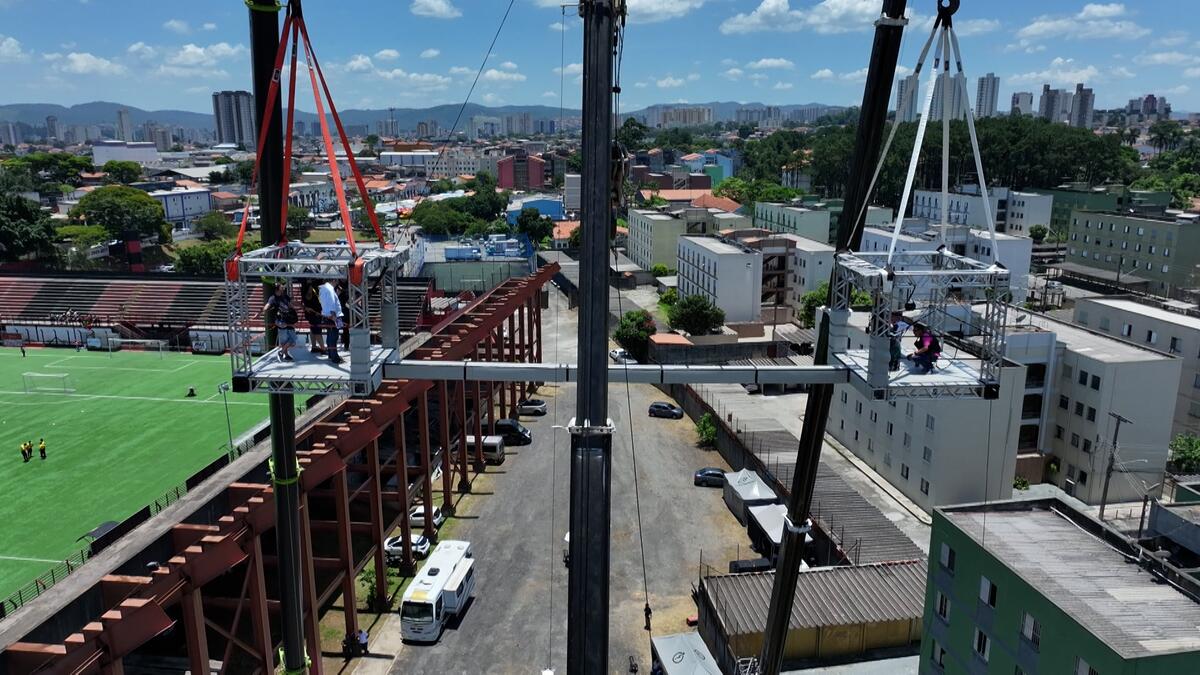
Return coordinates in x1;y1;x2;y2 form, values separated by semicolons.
400;539;475;643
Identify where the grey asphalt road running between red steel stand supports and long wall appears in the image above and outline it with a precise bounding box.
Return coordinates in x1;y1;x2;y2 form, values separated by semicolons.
391;288;749;674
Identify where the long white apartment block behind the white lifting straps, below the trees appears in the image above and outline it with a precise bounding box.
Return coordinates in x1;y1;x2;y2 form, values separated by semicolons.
912;185;1054;235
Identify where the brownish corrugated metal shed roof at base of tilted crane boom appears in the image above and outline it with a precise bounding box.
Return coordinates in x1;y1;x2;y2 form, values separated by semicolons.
703;560;928;635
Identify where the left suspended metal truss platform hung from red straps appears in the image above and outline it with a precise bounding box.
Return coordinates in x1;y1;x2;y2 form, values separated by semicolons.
226;241;409;396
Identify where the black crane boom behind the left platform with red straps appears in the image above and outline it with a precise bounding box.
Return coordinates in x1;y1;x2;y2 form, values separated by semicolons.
247;0;304;674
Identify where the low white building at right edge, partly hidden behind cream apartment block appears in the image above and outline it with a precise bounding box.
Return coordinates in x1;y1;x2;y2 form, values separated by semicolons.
1074;295;1200;436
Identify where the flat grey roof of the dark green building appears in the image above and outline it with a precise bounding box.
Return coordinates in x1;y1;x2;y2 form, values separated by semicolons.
940;500;1200;658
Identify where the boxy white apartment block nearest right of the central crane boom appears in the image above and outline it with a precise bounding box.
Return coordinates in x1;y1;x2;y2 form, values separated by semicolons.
676;237;762;323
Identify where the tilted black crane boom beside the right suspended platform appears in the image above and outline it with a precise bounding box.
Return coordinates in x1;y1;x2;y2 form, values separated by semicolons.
758;0;907;675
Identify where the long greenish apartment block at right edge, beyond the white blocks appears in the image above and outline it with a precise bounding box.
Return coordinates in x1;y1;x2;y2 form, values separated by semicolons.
1066;210;1200;294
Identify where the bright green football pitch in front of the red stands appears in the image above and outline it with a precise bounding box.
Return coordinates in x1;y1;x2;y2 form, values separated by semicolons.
0;347;268;599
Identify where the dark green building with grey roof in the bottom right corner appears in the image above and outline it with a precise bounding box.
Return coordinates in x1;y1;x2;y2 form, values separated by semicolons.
920;490;1200;675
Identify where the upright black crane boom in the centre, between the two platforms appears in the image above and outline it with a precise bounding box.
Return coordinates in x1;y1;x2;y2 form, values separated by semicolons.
566;0;625;675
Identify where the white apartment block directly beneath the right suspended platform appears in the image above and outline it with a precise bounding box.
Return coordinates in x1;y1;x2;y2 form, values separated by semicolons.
828;312;1025;510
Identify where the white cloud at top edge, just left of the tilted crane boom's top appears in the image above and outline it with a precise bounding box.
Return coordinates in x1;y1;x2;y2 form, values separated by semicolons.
721;0;880;35
